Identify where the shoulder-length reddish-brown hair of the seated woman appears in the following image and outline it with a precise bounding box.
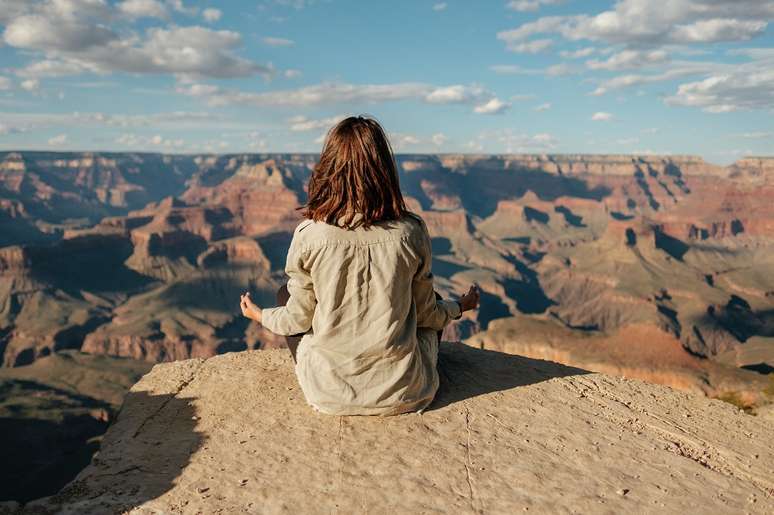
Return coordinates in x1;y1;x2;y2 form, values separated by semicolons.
301;116;407;229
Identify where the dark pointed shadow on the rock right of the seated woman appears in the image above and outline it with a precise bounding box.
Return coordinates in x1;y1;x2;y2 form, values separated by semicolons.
427;342;591;411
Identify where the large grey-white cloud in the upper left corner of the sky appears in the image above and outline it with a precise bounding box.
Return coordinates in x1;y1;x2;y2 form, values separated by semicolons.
3;0;274;78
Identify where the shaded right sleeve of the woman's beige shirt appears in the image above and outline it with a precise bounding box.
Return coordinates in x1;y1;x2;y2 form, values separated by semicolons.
412;218;462;331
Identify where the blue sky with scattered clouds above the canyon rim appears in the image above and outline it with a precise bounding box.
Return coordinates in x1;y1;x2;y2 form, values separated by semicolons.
0;0;774;163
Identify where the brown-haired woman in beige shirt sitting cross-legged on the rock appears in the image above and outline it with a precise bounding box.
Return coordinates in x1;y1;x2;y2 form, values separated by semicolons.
241;116;479;415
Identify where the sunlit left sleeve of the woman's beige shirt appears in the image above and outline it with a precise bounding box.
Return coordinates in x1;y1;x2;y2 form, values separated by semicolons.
261;232;317;336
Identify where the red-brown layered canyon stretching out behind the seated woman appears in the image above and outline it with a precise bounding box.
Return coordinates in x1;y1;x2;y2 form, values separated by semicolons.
0;152;774;504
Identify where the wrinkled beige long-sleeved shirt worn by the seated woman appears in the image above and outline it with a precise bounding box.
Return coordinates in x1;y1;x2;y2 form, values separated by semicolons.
263;214;460;415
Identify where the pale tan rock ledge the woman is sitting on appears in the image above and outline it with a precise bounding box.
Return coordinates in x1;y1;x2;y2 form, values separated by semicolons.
23;343;774;514
